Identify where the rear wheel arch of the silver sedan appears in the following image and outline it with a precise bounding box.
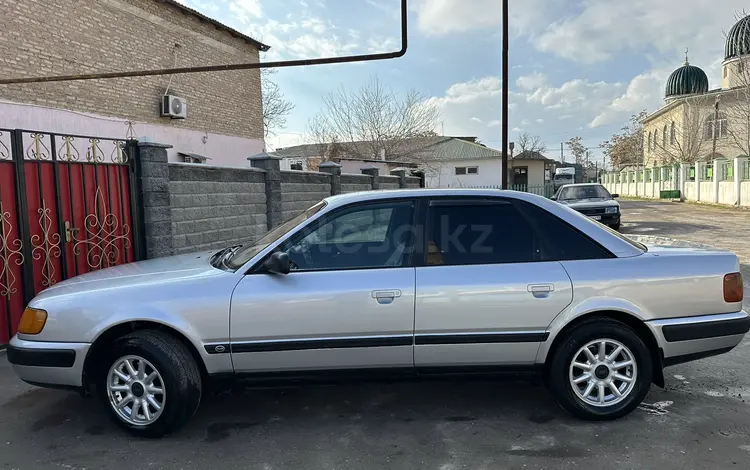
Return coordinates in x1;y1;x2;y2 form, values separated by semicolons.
537;310;664;387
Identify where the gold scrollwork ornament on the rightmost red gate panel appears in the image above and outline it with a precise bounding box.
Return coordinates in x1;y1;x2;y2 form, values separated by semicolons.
73;187;130;269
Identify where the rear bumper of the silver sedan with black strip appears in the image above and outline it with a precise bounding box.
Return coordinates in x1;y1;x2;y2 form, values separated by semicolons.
646;311;750;366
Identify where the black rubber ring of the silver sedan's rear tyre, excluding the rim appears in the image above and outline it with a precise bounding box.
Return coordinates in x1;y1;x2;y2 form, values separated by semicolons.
549;319;653;420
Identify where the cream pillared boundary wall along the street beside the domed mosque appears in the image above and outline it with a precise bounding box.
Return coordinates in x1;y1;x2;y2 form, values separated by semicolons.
602;157;750;207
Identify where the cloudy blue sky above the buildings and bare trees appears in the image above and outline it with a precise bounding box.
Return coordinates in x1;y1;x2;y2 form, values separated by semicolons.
175;0;746;165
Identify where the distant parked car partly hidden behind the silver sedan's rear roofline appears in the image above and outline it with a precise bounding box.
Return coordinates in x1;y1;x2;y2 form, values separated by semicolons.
552;183;621;230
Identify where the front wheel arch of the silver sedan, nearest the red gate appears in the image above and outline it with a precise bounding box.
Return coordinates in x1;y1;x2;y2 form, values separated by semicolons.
82;320;208;390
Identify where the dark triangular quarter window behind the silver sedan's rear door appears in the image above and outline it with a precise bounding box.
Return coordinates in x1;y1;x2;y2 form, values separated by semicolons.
516;201;613;261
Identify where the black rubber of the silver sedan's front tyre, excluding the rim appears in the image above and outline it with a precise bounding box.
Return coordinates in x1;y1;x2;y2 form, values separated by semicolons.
97;333;201;437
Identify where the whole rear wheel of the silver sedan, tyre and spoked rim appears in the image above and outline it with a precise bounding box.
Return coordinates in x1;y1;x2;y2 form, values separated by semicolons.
547;317;653;421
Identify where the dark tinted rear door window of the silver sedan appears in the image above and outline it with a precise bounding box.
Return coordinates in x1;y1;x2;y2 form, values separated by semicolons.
426;201;540;266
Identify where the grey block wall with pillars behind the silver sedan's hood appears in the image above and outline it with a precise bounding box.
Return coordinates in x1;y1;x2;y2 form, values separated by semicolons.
138;142;421;258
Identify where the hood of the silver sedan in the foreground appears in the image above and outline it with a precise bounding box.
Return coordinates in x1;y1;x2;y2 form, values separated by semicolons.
37;250;227;300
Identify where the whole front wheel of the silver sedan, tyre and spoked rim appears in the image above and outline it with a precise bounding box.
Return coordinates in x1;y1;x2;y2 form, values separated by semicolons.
97;330;202;438
